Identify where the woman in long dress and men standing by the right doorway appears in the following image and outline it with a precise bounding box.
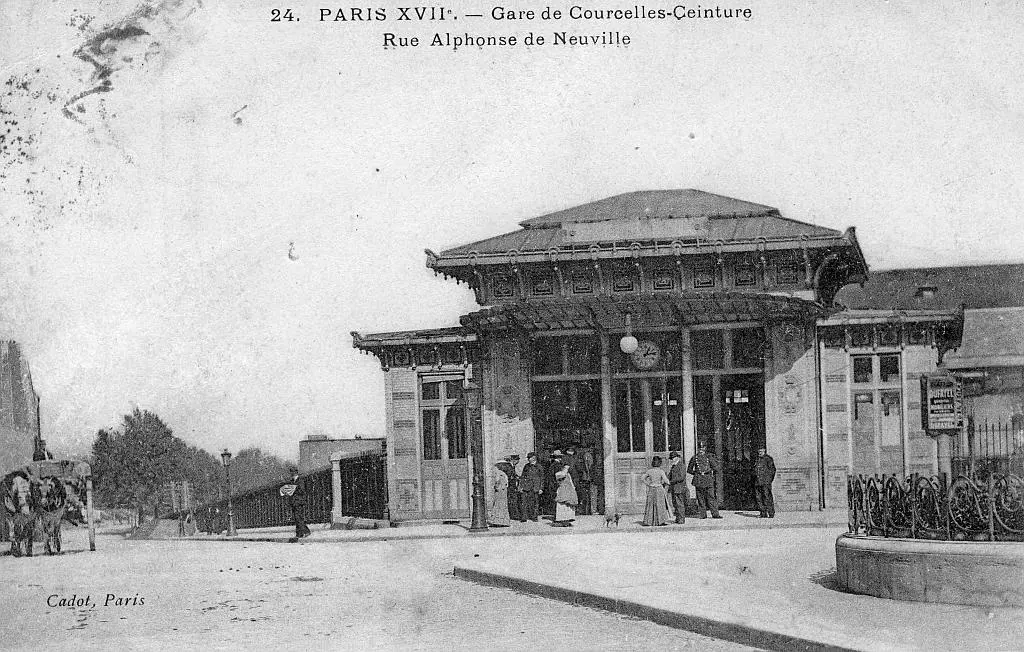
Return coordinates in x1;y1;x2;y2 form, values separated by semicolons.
642;443;775;525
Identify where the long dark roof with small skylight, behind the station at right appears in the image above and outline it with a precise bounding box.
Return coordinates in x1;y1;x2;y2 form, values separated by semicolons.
836;264;1024;310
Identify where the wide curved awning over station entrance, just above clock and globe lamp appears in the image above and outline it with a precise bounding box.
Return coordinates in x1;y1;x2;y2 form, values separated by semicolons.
460;292;828;331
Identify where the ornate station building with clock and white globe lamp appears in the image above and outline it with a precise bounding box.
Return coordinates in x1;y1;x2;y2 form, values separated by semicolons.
352;189;1024;521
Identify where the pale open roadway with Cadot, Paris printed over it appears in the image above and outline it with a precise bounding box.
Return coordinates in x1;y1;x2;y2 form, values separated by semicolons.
0;530;744;650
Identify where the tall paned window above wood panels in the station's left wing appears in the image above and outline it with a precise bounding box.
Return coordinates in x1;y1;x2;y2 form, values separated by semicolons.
420;376;467;460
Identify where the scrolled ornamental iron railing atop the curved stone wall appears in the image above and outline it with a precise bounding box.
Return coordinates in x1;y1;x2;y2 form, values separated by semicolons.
847;473;1024;541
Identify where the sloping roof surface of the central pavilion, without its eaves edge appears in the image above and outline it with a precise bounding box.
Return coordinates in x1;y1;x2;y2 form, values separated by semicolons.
439;189;843;260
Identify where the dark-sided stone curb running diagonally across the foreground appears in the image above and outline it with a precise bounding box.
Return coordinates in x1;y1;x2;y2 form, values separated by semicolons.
454;566;854;652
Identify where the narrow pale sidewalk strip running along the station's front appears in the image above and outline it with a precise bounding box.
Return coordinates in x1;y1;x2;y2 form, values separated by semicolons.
186;510;847;544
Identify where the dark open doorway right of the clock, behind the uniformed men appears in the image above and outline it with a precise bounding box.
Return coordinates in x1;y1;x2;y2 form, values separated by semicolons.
693;374;765;510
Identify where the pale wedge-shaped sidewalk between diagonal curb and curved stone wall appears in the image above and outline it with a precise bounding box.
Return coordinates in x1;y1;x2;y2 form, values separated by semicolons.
455;527;1024;650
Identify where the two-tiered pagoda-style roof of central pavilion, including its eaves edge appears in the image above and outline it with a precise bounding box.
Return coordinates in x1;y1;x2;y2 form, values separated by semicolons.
427;189;866;269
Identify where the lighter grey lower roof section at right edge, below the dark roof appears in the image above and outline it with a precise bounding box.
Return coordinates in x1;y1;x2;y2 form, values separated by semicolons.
943;308;1024;370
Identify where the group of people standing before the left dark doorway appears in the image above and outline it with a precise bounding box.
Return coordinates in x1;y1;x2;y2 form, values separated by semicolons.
488;445;593;527
